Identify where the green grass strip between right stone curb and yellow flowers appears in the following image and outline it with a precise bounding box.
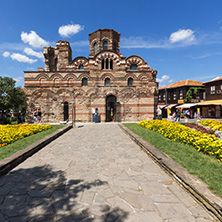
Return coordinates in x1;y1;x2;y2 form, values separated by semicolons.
124;123;222;197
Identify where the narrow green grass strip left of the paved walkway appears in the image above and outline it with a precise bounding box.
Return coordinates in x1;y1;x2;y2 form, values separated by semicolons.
0;125;64;160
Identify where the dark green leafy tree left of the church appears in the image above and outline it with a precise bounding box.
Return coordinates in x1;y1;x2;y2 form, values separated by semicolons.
0;76;26;123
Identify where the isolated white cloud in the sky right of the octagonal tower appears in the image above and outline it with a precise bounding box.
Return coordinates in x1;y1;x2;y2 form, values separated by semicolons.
169;29;195;43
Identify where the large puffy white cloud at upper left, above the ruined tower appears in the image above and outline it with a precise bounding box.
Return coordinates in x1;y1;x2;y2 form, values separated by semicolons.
21;31;49;48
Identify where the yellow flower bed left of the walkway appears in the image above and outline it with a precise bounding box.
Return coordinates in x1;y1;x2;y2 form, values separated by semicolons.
0;124;52;147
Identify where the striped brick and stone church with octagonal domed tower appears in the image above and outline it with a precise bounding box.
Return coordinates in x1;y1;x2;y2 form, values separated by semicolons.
24;29;158;122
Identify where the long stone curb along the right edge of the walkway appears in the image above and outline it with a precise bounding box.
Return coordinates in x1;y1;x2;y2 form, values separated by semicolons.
119;124;222;221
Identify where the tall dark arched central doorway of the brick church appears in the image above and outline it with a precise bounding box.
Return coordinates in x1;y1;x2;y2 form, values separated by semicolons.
106;95;116;122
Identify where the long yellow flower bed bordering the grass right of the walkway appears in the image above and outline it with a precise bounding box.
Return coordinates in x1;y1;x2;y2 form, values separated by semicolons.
138;120;222;161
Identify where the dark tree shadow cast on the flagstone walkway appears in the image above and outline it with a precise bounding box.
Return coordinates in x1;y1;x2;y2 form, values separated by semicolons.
0;166;128;222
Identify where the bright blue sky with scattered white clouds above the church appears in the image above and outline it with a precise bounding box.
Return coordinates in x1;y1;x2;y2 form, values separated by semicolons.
0;0;222;87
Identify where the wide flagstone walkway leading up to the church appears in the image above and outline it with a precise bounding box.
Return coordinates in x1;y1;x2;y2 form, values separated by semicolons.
0;124;217;222
